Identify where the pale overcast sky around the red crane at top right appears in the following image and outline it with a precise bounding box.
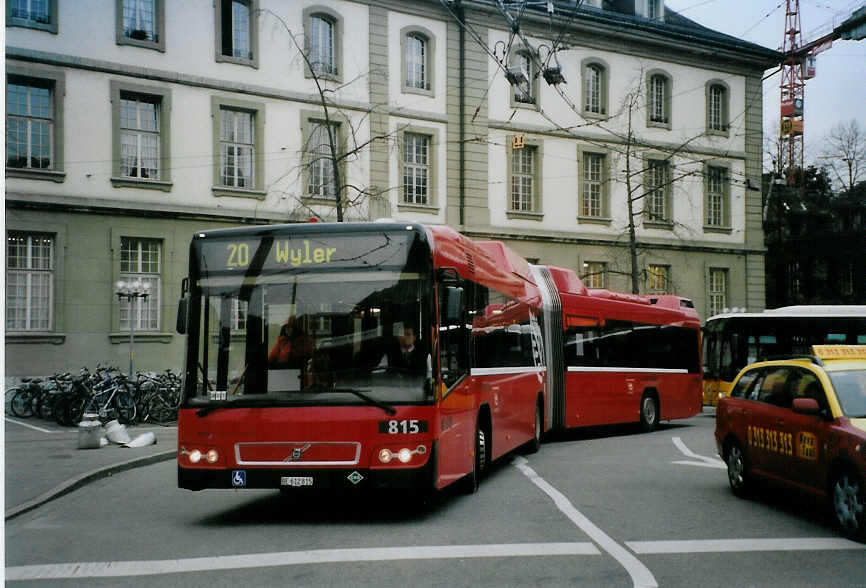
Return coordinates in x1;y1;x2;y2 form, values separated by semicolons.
665;0;866;165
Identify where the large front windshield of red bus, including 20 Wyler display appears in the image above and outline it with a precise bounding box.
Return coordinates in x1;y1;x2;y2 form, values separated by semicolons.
186;232;433;410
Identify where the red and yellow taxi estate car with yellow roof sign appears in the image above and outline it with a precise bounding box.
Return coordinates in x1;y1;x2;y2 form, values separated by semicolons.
715;345;866;541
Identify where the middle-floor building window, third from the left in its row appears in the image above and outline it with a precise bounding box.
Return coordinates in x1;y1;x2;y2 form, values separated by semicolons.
219;108;256;188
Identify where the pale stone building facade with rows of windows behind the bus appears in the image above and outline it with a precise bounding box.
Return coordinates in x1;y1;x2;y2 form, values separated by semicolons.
5;0;779;376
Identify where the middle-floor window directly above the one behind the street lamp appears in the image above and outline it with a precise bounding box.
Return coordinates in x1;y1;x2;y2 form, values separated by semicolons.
120;92;160;179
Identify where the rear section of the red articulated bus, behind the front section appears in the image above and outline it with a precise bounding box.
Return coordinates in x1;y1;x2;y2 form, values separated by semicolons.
533;266;702;431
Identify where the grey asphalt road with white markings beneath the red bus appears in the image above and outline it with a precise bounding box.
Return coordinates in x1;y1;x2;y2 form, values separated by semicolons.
5;412;866;588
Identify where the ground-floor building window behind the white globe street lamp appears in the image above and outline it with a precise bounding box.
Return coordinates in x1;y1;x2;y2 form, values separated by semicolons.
120;237;162;331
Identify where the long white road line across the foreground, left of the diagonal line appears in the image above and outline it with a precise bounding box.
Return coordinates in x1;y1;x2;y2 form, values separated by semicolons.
6;542;601;581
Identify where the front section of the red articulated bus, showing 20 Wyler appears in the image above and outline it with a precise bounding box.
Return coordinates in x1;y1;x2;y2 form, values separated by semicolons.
178;222;548;492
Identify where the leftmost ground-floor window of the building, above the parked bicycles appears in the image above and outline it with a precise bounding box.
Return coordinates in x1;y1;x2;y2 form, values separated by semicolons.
6;231;54;331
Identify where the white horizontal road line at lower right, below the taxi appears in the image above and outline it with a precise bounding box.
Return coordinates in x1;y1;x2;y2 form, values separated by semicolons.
626;537;866;555
